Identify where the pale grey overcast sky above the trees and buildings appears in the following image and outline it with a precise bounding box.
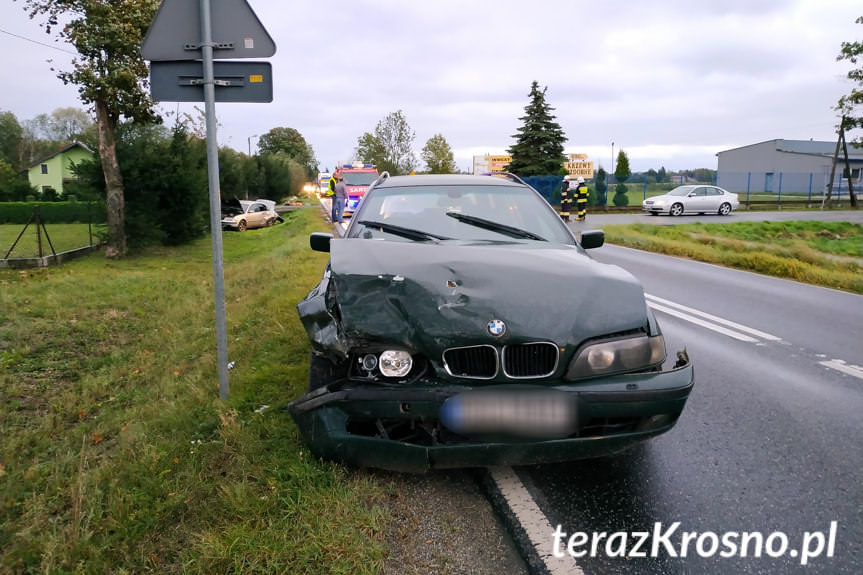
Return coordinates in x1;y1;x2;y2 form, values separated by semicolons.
0;0;863;171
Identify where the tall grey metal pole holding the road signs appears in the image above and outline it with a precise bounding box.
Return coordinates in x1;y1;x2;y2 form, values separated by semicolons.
201;0;228;400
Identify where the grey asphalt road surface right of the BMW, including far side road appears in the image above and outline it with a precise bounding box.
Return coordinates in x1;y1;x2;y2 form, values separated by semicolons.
516;244;863;574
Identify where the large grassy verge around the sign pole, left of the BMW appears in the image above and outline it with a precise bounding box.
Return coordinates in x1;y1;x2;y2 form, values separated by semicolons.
0;209;388;574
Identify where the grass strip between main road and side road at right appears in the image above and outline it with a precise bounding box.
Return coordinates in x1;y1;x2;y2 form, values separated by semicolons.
603;221;863;293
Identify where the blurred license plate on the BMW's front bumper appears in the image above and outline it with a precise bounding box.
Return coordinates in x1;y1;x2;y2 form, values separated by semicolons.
440;390;576;439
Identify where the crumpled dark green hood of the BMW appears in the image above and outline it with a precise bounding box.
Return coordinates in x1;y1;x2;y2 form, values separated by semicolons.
298;238;648;356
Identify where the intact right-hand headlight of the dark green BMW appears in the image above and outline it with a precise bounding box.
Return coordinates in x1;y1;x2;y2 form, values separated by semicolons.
566;335;665;379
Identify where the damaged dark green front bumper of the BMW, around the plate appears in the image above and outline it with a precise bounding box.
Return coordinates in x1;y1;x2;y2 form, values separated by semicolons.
288;355;694;473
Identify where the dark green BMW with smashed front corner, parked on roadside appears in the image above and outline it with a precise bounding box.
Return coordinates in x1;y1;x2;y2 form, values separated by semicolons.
289;173;694;472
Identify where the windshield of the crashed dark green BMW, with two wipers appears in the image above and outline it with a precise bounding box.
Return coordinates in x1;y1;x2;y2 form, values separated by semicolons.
349;185;575;245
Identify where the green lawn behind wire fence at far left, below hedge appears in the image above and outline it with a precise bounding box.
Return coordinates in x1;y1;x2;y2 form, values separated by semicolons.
0;223;104;258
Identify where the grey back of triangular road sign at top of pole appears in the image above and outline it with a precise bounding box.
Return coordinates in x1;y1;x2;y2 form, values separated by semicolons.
141;0;276;61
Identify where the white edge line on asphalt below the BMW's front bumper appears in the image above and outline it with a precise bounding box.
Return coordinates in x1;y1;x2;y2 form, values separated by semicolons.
488;467;584;575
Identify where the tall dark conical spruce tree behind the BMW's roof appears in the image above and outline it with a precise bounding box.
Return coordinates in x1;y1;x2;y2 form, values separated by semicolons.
507;80;566;176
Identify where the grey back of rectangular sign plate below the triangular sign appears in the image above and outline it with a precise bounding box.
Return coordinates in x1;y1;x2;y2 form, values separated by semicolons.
150;60;273;103
